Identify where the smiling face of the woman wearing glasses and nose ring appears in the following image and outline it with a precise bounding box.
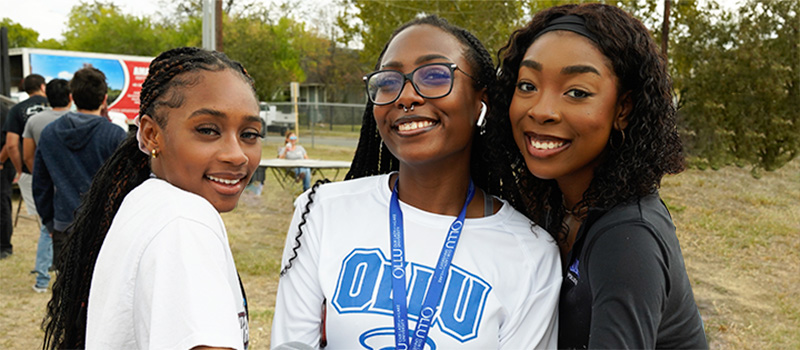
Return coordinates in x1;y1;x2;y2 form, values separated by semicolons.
373;25;484;165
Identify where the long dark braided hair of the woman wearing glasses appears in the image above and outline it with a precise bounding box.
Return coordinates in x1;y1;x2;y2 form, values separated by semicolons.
281;15;510;275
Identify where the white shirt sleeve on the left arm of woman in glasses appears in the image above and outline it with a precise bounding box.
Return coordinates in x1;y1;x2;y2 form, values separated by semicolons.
271;193;324;348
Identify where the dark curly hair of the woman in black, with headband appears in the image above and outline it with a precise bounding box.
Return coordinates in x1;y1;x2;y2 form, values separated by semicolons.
489;4;684;239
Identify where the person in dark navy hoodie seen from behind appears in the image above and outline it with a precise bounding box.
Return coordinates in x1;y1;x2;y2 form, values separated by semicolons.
33;66;126;269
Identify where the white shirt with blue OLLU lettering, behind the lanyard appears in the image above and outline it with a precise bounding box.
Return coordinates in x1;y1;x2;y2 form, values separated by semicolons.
272;175;561;349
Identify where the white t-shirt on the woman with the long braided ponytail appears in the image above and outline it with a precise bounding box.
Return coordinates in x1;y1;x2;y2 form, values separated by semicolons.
86;178;249;349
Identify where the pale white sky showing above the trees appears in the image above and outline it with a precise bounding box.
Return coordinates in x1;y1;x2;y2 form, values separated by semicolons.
0;0;738;40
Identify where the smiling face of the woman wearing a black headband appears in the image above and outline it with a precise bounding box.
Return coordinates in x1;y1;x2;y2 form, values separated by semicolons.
509;31;630;193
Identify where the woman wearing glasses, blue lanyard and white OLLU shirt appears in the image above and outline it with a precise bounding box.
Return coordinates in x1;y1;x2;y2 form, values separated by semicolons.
272;16;561;349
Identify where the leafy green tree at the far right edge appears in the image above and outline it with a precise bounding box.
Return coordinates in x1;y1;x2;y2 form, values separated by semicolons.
671;0;800;175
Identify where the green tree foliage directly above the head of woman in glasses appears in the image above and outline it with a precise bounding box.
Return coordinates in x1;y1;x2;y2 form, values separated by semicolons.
339;0;525;65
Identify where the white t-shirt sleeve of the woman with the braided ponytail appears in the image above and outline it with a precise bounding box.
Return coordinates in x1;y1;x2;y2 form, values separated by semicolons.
133;218;244;349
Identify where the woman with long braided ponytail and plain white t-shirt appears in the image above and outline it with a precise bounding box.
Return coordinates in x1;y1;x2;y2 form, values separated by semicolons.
44;48;262;349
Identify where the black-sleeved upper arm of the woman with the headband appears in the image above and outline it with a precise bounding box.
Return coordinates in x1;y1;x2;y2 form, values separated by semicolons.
586;223;669;349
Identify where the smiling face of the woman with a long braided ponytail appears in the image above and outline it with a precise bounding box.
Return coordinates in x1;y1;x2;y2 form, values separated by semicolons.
142;69;261;212
